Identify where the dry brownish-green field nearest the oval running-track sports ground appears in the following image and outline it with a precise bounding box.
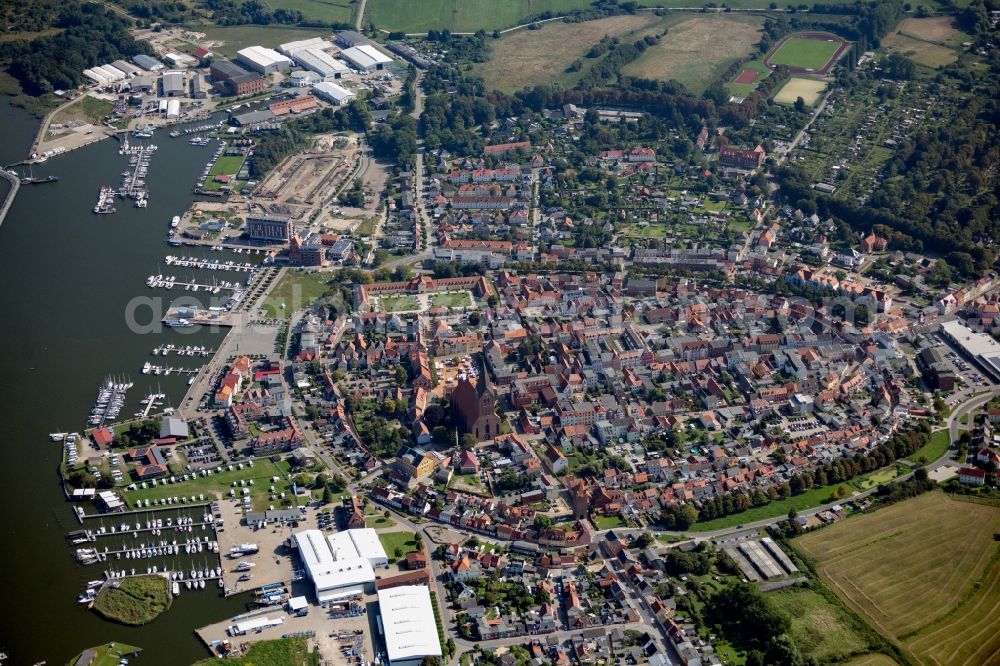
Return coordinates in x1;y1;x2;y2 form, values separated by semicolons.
623;14;763;93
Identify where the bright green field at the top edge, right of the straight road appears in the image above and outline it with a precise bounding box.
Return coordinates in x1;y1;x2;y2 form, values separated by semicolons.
368;0;593;33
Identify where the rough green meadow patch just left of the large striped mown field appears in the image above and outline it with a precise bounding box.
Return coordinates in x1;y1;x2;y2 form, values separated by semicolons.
767;587;868;663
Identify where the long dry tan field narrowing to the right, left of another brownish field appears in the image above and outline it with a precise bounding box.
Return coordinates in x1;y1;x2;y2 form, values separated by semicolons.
474;14;659;92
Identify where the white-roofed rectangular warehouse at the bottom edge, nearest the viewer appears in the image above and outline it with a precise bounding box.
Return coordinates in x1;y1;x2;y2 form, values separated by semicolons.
378;585;441;666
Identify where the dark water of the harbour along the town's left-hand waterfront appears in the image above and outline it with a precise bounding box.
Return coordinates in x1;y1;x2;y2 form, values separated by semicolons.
0;97;254;666
